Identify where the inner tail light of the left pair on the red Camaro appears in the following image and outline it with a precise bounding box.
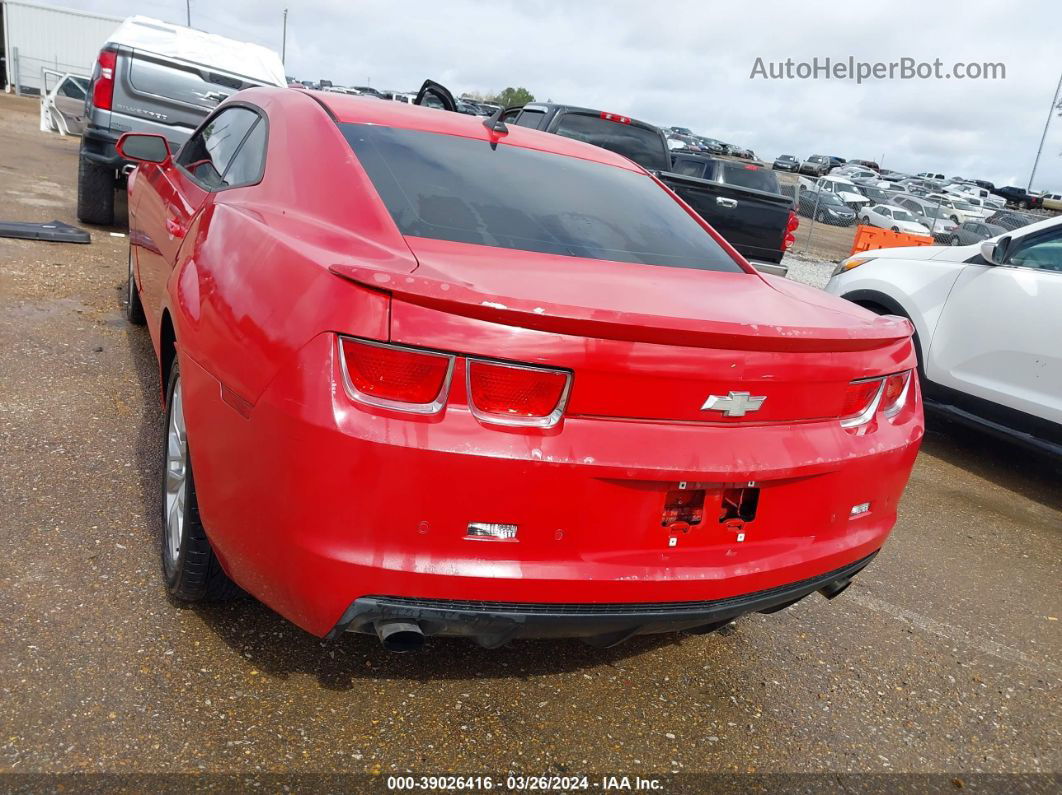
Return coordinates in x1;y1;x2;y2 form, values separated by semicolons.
465;359;571;428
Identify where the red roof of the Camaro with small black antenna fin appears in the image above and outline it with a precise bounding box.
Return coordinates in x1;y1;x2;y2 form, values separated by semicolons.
307;89;644;172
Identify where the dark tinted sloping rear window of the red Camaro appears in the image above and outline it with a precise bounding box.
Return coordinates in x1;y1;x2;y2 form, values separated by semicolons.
340;123;742;273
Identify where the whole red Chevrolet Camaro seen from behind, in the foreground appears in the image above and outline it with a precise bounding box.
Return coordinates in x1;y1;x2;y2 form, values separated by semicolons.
120;88;923;650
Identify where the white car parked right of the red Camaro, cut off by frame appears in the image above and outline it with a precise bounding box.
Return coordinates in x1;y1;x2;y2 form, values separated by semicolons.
826;219;1062;456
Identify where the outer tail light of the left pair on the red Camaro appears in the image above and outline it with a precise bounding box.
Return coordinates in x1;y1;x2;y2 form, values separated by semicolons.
340;336;455;414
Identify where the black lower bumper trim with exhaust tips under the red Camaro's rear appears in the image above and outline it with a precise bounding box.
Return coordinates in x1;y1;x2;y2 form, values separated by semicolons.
327;552;877;649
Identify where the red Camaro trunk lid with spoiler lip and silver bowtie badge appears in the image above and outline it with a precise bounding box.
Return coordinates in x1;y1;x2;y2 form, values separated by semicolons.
332;238;911;424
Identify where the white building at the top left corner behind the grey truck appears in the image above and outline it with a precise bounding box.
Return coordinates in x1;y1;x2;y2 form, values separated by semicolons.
0;0;122;93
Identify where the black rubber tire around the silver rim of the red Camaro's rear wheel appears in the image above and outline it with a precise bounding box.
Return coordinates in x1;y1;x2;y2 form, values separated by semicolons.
160;360;241;602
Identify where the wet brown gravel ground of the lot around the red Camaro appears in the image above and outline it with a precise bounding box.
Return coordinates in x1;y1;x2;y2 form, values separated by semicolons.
0;96;1062;791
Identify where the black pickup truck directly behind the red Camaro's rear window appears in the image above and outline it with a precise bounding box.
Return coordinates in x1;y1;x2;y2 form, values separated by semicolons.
415;81;797;270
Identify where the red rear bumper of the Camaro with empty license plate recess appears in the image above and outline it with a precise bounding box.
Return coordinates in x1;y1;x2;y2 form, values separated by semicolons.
182;334;922;637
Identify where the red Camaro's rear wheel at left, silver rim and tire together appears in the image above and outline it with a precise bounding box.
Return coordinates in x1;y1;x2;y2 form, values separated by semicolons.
161;361;240;602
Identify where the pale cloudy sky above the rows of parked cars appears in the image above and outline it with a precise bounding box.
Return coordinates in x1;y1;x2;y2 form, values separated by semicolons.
64;0;1062;191
